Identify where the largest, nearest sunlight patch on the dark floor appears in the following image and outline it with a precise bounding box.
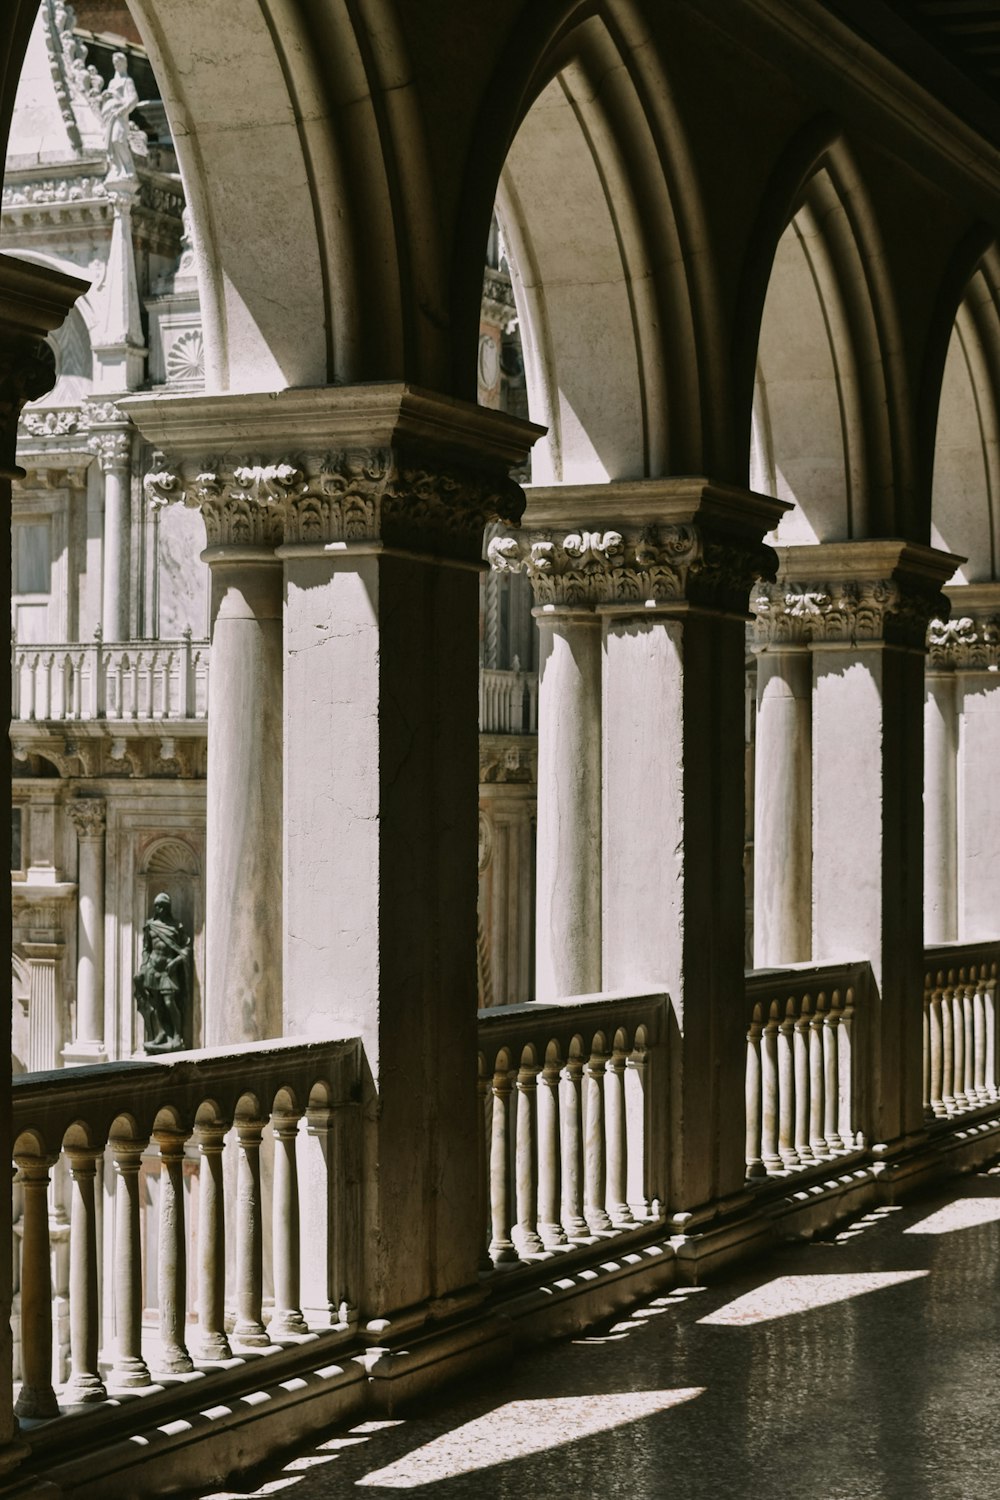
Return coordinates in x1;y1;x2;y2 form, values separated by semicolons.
355;1386;705;1490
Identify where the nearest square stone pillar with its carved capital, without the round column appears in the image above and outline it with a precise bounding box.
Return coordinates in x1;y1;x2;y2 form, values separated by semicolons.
129;386;537;1337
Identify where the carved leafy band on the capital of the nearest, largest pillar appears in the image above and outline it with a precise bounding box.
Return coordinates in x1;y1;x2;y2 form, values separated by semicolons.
144;447;523;561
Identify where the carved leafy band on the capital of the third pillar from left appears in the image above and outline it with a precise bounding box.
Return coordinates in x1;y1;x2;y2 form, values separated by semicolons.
750;579;942;650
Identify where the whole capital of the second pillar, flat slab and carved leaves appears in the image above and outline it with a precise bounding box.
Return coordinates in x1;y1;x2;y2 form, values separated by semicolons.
487;479;787;614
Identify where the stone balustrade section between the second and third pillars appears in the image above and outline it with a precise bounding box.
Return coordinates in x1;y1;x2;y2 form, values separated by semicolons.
747;963;871;1178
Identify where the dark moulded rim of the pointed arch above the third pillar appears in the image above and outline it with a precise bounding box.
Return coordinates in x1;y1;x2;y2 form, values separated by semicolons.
733;116;915;537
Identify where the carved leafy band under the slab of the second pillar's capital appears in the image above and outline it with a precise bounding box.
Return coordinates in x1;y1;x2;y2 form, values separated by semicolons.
487;525;774;612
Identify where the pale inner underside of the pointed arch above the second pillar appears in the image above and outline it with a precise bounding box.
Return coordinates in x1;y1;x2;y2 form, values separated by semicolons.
496;18;703;485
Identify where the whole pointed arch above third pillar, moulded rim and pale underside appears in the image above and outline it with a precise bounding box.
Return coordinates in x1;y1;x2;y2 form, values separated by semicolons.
733;117;915;540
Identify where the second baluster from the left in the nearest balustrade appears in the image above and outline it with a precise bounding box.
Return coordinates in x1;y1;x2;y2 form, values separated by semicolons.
63;1146;106;1404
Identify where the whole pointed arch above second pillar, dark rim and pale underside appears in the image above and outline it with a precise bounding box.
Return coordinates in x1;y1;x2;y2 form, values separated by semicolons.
451;0;727;482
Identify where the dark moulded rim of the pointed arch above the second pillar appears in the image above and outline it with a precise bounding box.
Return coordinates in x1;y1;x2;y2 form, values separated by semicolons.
451;0;727;474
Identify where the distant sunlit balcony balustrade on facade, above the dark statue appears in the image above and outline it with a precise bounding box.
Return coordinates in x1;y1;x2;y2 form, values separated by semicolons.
10;635;208;722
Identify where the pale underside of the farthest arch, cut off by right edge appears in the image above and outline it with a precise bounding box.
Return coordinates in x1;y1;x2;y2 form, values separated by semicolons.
931;266;1000;584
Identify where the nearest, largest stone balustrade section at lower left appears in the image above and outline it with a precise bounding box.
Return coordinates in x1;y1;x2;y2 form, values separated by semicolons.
13;1038;360;1418
